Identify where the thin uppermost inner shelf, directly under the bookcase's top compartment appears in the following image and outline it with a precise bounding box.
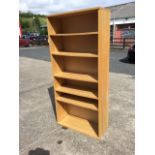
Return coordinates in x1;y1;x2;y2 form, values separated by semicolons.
50;32;98;37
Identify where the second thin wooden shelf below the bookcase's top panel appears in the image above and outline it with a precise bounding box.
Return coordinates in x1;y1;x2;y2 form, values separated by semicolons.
52;51;98;58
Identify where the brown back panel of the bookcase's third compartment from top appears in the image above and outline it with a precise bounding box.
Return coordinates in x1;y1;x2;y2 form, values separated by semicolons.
55;56;98;75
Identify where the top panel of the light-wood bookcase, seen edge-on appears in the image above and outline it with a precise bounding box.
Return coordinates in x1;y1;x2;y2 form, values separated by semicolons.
47;7;103;18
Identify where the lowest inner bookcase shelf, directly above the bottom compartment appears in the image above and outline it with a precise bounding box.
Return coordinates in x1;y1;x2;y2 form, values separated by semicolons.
56;94;98;111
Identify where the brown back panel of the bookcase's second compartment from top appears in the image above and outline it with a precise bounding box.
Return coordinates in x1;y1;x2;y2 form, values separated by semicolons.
52;35;98;53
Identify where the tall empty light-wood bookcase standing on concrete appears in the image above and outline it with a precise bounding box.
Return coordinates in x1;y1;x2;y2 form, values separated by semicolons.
47;8;110;138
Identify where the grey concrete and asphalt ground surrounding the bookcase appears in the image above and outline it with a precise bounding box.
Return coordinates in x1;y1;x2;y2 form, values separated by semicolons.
19;47;135;155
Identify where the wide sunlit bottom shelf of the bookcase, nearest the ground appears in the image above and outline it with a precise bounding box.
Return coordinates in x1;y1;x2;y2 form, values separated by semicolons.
58;115;99;138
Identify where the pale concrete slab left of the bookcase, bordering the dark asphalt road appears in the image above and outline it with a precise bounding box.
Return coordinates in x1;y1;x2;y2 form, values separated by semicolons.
19;57;52;92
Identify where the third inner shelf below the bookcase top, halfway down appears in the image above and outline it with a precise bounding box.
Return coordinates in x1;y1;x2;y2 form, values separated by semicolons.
54;72;98;83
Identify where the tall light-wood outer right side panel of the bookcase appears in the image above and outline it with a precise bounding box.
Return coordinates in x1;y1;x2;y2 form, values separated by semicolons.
98;9;110;137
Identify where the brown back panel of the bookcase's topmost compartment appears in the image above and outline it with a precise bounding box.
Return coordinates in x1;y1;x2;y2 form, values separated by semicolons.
49;11;98;34
